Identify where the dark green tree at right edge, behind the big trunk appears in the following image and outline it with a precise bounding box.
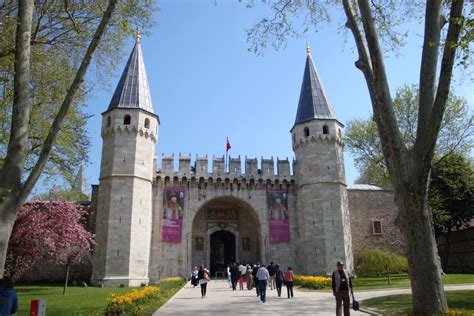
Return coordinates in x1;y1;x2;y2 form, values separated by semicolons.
429;153;474;235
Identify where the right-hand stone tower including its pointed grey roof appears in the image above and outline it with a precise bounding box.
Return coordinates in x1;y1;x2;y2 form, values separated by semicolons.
290;47;353;275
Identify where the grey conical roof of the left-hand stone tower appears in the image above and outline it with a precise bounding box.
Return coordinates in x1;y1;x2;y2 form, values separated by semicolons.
107;36;154;113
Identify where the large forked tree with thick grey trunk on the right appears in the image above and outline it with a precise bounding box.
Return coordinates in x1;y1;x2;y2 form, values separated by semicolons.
248;0;474;314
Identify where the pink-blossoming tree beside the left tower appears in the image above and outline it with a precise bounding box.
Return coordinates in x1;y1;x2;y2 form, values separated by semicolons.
5;201;94;281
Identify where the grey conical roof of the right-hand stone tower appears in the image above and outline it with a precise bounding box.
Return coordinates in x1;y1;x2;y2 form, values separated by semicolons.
295;47;336;125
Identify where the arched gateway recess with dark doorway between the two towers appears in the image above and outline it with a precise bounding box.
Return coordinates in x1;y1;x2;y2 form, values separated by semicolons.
192;196;263;275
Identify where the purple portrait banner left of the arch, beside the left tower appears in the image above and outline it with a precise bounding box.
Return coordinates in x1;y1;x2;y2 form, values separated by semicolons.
161;187;184;244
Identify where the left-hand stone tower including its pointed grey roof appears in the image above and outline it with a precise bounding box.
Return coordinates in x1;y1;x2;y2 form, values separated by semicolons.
92;36;160;286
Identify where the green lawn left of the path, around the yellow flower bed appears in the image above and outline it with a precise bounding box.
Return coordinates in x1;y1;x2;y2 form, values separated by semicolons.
15;283;182;316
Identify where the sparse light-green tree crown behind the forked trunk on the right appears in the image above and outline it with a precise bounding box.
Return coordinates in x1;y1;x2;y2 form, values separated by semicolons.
345;85;474;188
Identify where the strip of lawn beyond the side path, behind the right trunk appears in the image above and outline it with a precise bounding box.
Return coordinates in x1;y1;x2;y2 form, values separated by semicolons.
352;274;474;290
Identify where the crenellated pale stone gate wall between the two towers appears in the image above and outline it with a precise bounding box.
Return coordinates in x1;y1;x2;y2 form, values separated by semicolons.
149;174;301;282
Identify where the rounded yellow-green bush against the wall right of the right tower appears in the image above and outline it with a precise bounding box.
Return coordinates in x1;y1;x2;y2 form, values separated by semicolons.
355;249;408;284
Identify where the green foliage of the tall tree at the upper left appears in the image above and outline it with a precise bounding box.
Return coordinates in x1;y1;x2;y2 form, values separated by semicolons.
0;0;153;181
